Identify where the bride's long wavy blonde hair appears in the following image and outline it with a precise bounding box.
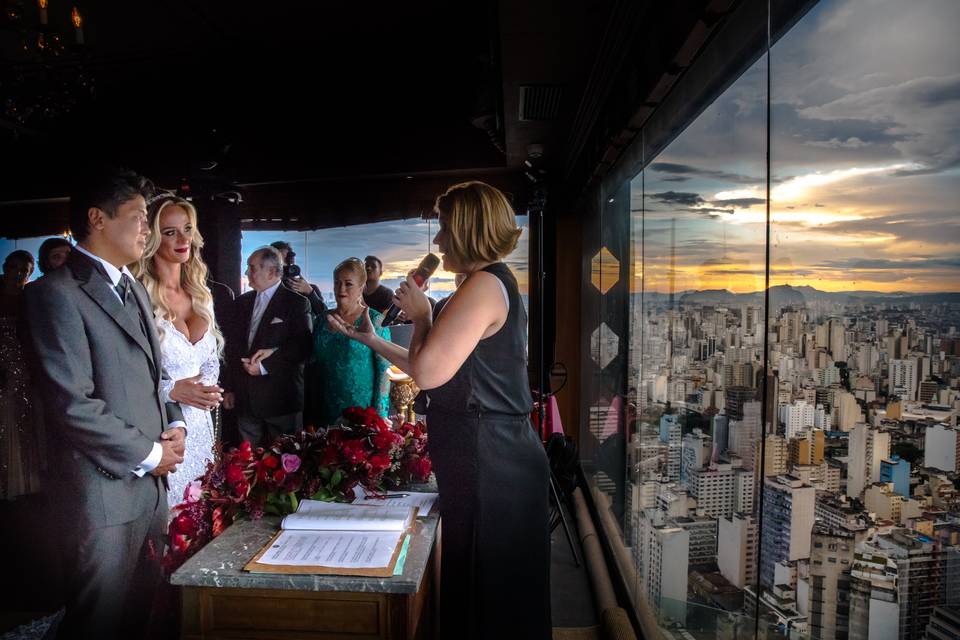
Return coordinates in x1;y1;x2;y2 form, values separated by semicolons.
132;196;223;354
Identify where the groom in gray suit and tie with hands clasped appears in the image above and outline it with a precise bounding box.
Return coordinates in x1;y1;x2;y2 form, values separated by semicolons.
26;170;186;638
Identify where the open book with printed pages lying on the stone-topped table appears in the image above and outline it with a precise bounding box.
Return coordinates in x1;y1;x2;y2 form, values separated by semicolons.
244;500;417;576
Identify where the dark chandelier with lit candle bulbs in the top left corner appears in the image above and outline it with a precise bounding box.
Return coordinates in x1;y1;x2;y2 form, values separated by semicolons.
0;0;94;133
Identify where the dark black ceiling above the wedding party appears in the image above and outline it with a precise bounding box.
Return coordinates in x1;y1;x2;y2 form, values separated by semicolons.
0;0;609;228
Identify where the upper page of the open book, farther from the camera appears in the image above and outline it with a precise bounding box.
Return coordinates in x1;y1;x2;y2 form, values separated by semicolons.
280;500;413;531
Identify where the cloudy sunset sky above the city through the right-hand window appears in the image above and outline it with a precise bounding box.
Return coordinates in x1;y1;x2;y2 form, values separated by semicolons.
631;0;960;292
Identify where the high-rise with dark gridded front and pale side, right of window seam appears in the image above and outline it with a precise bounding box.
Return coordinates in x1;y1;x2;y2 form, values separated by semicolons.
760;475;816;588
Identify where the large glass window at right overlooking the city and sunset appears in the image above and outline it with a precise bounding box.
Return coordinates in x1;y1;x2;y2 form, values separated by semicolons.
583;0;960;638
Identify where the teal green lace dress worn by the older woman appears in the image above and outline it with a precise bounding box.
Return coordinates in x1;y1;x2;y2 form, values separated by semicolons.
311;309;390;426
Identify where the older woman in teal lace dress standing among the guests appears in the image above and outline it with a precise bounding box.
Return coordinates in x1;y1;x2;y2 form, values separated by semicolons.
313;258;390;426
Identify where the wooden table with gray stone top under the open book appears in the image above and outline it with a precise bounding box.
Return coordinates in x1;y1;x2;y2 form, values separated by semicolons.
170;515;439;640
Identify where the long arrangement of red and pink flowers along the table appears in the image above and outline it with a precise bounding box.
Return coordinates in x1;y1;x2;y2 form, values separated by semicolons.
164;407;431;572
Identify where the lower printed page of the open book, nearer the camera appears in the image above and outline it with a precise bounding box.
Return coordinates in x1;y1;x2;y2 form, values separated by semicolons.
258;531;404;569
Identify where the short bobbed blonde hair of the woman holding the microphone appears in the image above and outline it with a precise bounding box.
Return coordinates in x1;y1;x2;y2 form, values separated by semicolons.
434;181;522;265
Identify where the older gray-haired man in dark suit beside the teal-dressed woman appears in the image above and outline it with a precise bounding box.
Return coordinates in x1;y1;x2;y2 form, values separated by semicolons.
224;247;313;446
